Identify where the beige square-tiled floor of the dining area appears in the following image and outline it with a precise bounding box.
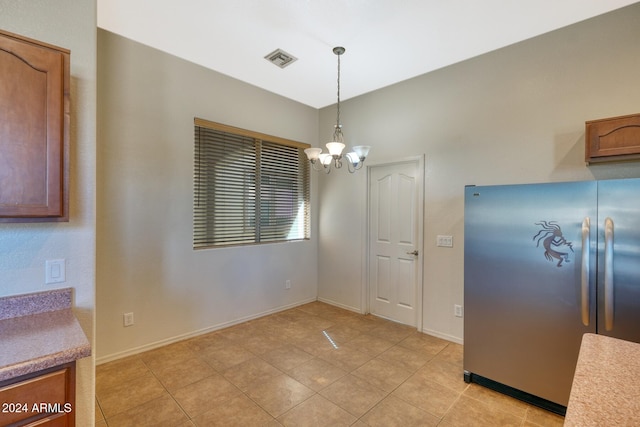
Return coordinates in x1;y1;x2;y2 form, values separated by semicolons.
96;302;563;427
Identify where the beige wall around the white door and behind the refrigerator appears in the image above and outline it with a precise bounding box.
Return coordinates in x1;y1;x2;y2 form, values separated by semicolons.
318;4;640;342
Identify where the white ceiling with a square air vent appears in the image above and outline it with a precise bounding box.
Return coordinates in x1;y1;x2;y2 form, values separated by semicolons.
97;0;637;108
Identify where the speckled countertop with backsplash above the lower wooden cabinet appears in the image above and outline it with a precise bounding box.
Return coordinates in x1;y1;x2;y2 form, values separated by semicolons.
0;288;91;381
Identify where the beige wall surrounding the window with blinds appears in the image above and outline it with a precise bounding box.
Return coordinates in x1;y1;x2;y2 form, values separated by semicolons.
97;30;318;363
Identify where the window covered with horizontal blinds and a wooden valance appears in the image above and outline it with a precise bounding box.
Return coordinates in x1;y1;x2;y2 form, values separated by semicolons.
193;119;309;249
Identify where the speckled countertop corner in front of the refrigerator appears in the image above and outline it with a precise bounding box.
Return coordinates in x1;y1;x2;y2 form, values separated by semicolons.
564;334;640;427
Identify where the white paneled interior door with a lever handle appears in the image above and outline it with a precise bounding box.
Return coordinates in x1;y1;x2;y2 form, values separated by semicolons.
368;160;422;326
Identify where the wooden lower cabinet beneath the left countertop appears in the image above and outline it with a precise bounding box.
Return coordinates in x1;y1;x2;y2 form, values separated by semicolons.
0;362;75;427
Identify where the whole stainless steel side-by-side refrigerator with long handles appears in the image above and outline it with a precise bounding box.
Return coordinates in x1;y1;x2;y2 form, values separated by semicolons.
464;179;640;414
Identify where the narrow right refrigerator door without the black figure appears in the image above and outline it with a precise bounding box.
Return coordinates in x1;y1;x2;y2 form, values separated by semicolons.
598;179;640;342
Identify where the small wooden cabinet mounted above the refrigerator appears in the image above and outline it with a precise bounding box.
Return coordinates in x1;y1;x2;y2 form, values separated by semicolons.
585;114;640;163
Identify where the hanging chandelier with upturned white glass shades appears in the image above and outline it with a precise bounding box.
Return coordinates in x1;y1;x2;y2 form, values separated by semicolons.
304;46;371;173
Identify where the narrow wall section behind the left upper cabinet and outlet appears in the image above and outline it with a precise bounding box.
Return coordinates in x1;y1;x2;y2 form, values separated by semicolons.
0;0;96;426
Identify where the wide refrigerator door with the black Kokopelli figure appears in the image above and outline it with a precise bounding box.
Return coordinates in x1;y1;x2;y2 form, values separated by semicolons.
464;182;597;406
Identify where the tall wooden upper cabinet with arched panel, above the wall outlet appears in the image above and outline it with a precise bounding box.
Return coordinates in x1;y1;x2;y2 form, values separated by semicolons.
0;31;70;222
